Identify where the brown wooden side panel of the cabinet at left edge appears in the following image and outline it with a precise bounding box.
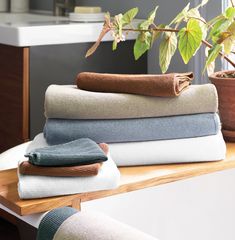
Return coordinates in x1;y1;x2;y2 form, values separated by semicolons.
0;44;29;152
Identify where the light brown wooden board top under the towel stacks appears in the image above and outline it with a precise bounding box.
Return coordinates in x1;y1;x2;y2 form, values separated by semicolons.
0;143;235;215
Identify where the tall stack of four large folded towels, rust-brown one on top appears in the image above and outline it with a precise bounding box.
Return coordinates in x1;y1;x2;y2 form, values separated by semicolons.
44;73;226;166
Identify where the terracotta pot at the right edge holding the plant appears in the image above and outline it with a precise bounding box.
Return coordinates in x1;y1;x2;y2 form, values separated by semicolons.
209;71;235;142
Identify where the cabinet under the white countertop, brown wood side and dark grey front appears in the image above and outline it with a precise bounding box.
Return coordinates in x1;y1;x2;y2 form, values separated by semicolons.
0;40;147;152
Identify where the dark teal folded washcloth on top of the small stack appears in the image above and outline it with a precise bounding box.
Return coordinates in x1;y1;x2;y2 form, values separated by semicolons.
25;138;107;166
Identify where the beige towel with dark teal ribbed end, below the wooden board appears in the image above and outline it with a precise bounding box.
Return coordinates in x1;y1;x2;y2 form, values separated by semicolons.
37;207;157;240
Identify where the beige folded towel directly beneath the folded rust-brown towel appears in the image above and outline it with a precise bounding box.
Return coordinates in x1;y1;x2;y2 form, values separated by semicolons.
45;84;218;119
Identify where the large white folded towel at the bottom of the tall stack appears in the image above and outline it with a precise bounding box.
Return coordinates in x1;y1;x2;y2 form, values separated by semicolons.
109;132;226;166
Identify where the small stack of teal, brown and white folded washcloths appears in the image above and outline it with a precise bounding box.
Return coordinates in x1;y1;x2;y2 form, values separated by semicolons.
18;135;120;199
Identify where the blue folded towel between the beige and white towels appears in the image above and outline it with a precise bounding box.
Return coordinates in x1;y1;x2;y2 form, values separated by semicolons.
44;113;220;145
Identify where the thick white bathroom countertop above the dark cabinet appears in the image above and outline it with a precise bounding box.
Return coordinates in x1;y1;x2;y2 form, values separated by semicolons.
0;13;139;47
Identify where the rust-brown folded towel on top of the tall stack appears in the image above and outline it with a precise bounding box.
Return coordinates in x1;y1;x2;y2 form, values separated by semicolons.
77;72;193;97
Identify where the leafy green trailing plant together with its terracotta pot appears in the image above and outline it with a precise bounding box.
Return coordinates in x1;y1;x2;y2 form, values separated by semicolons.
86;0;235;141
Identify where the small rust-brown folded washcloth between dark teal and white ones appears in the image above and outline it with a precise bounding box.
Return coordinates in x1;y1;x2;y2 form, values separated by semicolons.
19;161;102;177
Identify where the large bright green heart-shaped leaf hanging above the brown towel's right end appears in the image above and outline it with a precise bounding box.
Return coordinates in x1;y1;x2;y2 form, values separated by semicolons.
178;19;203;64
